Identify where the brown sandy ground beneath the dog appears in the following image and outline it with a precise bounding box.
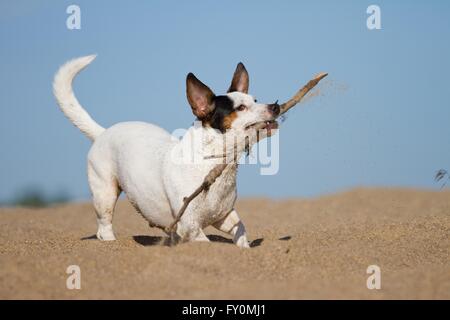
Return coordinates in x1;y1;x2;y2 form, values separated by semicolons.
0;189;450;299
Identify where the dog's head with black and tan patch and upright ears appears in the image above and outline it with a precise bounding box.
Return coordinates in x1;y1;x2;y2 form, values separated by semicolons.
186;63;280;134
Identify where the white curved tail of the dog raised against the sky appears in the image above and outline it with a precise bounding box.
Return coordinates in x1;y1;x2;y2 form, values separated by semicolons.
53;55;105;141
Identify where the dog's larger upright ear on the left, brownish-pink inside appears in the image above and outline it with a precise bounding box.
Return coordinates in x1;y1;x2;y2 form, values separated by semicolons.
186;73;214;120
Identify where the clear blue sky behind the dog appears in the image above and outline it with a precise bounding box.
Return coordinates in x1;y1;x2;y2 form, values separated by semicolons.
0;0;450;200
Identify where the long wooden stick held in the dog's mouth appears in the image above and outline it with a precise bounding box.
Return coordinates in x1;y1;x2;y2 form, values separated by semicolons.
165;73;328;233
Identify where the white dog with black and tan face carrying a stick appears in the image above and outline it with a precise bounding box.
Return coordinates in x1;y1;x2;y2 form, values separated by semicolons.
53;55;280;247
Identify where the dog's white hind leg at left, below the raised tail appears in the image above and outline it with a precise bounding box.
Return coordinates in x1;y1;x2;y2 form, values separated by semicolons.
88;165;121;241
